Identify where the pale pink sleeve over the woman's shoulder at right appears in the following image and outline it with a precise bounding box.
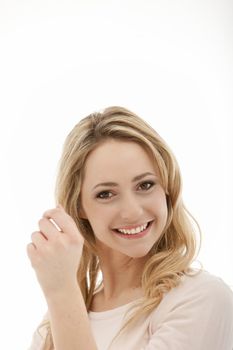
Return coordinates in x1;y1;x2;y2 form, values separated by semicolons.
144;280;233;350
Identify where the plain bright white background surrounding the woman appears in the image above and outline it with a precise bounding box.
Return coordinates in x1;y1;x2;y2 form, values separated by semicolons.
0;0;233;350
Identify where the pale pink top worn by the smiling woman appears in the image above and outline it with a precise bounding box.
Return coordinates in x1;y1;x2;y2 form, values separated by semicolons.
29;271;233;350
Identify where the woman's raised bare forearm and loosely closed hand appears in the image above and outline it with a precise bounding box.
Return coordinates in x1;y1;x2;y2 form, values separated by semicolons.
27;207;97;350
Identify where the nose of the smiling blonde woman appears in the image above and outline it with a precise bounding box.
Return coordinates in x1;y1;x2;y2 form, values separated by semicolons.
120;194;143;224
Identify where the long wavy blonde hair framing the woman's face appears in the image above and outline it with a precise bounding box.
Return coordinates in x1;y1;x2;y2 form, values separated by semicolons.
37;106;201;350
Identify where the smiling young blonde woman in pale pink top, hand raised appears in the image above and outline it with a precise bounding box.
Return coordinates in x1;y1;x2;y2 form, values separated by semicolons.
27;107;233;350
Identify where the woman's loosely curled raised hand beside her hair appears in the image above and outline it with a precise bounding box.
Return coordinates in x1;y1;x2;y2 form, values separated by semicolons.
27;206;84;297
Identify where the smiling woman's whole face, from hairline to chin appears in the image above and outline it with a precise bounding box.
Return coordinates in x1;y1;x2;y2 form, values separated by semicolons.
81;139;167;258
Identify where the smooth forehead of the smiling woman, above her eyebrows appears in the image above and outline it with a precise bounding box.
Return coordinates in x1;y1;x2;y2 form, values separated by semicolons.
84;140;156;181
